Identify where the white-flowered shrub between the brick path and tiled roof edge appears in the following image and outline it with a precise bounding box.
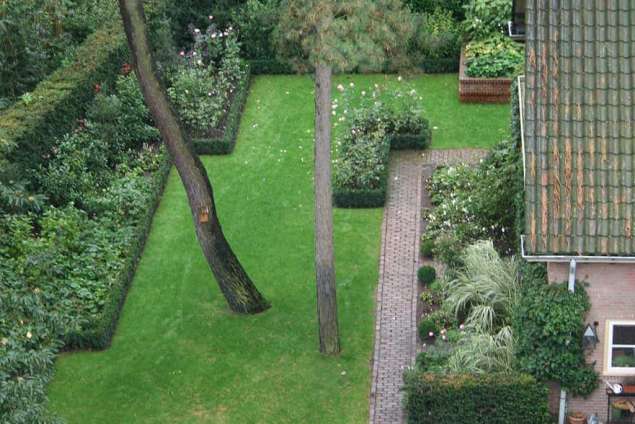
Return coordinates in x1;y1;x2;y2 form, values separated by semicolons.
424;137;523;264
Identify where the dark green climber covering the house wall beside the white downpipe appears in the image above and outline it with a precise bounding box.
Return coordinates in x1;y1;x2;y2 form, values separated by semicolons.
512;276;598;396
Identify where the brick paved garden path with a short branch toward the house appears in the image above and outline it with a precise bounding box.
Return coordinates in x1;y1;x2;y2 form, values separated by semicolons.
370;149;484;424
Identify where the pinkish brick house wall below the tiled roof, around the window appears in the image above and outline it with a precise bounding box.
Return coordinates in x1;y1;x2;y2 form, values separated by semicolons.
548;263;635;421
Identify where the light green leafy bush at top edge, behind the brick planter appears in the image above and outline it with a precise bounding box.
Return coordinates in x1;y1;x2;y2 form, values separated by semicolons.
463;0;512;40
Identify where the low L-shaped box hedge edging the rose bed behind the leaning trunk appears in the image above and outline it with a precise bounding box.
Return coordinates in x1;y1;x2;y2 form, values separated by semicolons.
192;66;251;155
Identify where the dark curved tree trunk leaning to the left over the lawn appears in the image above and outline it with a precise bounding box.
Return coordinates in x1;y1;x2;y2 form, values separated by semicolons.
119;0;269;313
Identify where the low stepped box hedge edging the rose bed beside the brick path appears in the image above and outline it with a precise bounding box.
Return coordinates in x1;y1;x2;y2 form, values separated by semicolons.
333;129;432;208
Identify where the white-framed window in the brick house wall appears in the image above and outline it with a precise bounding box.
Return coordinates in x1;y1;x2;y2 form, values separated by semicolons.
606;321;635;375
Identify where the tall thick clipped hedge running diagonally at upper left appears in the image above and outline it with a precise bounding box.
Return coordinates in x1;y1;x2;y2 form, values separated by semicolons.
0;20;127;184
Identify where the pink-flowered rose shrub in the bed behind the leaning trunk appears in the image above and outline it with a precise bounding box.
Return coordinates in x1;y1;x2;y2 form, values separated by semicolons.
168;24;246;134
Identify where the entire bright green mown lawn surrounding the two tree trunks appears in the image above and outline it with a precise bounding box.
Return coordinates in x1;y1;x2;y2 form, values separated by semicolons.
49;76;508;424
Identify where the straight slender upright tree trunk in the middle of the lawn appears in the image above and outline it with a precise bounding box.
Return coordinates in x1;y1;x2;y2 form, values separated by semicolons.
315;65;340;355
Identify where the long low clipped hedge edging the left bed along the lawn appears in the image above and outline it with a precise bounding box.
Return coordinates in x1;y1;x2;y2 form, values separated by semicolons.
63;155;172;349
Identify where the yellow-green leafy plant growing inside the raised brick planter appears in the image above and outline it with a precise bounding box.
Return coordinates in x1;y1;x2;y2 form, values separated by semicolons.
465;34;525;78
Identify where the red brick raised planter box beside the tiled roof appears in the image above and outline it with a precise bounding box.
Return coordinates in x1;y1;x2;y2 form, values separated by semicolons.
459;49;512;103
